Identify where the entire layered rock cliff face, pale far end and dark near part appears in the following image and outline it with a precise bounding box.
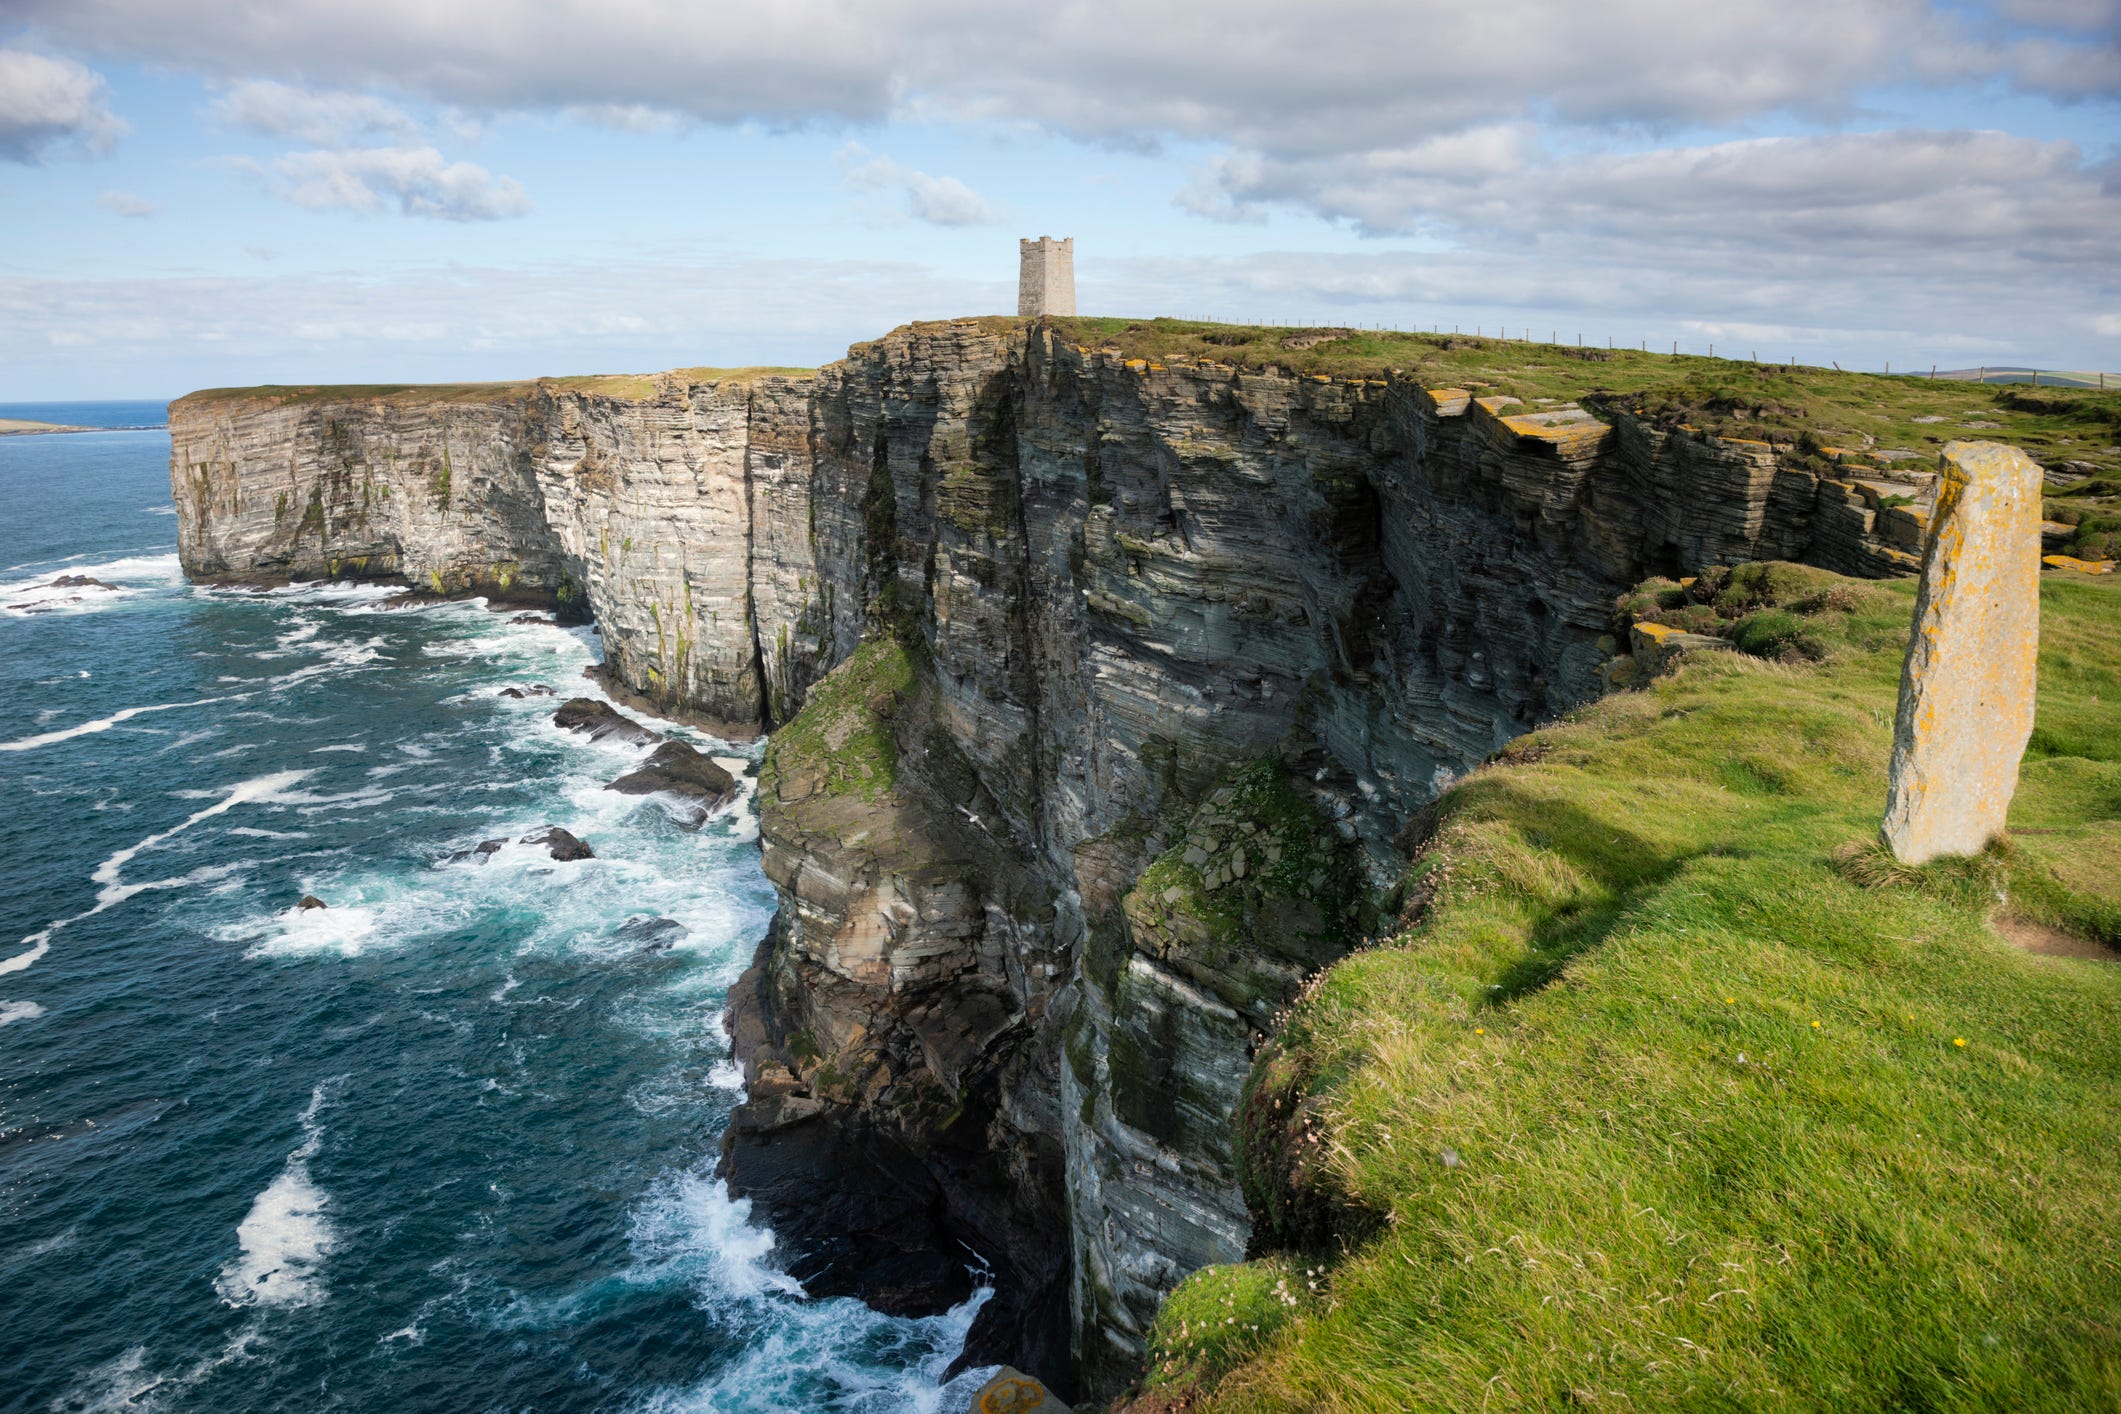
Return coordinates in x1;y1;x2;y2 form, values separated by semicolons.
172;320;1925;1389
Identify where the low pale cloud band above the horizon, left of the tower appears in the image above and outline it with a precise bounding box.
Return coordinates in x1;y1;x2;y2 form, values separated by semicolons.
0;253;1016;396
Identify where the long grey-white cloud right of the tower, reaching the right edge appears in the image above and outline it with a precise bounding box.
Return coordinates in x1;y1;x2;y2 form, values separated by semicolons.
1184;129;2121;286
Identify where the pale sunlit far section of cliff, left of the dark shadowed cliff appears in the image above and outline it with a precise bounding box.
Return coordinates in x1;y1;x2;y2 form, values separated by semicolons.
170;373;821;736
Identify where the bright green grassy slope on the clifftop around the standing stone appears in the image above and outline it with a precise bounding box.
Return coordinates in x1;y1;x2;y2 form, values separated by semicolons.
1141;575;2121;1410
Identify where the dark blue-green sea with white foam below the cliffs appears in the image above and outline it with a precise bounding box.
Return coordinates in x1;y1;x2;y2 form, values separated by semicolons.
0;403;986;1414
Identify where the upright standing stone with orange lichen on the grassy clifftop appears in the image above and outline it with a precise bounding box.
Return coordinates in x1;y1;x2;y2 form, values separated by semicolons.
1881;441;2040;865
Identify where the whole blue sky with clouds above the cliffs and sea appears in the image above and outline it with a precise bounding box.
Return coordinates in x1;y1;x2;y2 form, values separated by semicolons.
0;0;2121;401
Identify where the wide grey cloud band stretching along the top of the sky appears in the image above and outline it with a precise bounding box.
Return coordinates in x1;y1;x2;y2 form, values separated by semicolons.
11;0;2110;142
